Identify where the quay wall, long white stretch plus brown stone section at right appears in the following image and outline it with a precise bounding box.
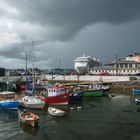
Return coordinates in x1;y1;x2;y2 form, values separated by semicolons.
0;75;140;90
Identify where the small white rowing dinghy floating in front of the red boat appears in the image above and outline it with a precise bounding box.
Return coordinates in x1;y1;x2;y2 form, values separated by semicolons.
48;107;66;117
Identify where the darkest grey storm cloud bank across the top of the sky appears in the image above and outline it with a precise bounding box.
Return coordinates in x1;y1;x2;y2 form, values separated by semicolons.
7;0;140;40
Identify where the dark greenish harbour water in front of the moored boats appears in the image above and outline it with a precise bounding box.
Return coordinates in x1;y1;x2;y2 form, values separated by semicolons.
0;91;140;140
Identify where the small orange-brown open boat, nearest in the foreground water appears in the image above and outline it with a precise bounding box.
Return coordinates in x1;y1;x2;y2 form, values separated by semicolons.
18;109;39;127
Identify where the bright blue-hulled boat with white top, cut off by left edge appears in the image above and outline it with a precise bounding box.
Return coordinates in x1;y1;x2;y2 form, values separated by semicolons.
0;91;19;109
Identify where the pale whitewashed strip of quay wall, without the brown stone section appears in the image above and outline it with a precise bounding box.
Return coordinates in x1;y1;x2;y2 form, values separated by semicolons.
0;75;129;82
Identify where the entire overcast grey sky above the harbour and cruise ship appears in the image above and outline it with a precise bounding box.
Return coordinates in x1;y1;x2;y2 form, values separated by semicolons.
0;0;140;69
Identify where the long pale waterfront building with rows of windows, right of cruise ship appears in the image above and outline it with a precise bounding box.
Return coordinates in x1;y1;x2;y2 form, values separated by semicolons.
89;54;140;75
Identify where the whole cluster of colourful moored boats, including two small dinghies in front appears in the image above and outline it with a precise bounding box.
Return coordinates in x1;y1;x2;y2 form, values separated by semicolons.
0;82;110;127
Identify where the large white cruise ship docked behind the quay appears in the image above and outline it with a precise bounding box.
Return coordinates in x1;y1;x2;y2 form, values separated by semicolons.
74;55;100;74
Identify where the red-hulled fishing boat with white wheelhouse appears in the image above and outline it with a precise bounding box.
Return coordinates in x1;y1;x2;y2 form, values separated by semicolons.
39;86;69;105
